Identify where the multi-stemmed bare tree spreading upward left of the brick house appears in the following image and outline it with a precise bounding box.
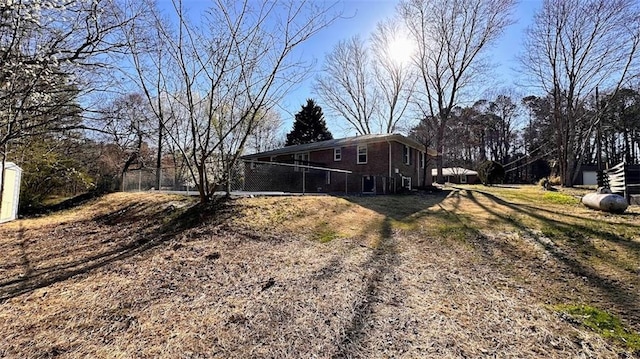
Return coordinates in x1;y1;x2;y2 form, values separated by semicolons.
122;0;335;202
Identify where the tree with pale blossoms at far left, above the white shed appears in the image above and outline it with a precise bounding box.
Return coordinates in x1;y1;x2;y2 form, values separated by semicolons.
0;0;142;214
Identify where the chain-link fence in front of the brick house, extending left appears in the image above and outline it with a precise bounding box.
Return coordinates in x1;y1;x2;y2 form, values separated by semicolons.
122;161;402;195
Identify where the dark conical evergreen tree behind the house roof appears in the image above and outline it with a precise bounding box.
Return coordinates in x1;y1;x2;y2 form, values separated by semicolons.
286;99;333;146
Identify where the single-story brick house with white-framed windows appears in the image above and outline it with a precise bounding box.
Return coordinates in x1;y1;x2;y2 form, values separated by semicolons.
242;134;437;194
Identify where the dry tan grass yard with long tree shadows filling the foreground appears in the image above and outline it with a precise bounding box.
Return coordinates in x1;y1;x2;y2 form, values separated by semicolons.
0;187;640;358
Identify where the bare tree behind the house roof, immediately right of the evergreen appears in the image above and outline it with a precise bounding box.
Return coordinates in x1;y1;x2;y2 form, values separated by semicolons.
315;36;378;135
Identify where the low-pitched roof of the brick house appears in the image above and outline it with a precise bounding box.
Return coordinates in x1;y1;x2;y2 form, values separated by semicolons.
242;134;438;159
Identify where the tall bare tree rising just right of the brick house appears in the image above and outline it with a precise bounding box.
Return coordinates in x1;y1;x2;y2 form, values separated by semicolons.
398;0;515;182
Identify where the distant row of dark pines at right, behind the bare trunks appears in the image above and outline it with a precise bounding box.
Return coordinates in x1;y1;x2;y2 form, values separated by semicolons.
410;88;640;183
